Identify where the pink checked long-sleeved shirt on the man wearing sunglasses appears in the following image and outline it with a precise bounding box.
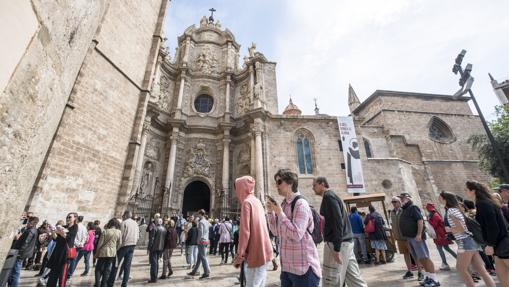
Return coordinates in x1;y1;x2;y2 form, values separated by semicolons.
268;192;322;278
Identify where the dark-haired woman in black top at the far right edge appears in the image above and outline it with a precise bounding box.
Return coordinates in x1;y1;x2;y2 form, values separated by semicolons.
465;181;509;287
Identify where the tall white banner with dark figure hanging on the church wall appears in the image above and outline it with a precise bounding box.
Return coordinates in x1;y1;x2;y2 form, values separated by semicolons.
338;117;366;193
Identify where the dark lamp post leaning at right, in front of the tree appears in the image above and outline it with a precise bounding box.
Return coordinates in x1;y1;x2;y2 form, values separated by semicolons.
452;50;509;182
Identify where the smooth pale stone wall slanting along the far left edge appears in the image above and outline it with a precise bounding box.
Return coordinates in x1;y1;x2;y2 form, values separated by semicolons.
0;0;107;264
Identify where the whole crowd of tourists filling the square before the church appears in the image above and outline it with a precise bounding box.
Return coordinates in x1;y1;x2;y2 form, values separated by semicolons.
6;169;509;287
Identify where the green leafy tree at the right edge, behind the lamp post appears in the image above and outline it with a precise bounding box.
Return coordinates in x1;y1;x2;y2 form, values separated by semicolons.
468;105;509;181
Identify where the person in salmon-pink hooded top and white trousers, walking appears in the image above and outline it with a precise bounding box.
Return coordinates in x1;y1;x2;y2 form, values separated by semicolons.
233;176;272;286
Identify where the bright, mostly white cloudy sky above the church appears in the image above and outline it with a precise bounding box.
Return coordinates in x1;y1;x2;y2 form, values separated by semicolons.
164;0;509;120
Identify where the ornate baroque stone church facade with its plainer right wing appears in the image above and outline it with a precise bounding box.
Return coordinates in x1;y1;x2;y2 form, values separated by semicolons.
123;17;488;220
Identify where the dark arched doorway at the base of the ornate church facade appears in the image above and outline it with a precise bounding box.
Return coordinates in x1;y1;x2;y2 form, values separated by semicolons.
182;180;210;215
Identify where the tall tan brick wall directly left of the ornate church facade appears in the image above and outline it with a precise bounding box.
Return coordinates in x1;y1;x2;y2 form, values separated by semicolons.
25;0;166;227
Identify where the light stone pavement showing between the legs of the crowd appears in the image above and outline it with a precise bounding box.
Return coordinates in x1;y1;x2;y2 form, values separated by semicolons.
20;241;500;287
